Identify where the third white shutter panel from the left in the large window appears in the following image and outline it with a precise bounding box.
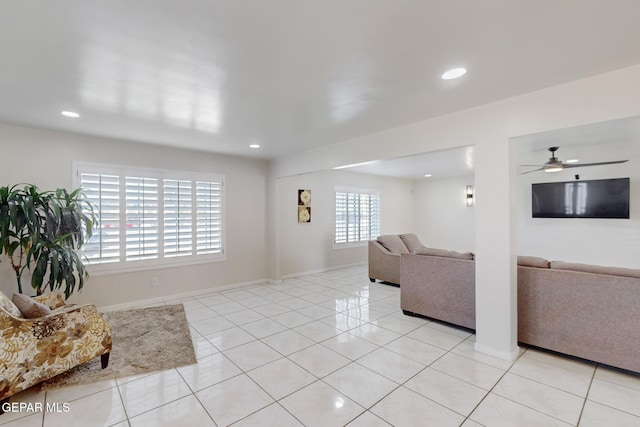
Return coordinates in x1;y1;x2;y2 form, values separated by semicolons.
163;179;193;257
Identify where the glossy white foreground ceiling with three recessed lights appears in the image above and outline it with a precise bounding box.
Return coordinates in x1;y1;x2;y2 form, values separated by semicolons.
0;0;640;158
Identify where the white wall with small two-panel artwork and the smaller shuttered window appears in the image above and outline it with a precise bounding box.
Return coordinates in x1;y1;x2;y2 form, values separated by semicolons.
277;171;413;277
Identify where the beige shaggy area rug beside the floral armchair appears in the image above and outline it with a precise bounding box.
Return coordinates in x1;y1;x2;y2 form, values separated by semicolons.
40;304;196;390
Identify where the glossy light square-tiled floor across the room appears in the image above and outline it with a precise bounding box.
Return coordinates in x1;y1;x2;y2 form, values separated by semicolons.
0;267;640;427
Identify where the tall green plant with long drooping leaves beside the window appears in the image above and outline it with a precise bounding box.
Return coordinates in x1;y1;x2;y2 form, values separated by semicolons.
0;185;96;298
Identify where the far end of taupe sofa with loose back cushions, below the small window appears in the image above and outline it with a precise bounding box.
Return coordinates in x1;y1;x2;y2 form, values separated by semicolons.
369;233;424;285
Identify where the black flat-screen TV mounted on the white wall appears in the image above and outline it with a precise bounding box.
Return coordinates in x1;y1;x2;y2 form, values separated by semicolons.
531;178;629;218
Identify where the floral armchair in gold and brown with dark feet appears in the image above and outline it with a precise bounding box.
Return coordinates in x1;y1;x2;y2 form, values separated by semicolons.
0;292;111;414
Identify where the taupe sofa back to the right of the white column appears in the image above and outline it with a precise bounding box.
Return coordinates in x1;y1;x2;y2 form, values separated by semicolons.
518;257;640;372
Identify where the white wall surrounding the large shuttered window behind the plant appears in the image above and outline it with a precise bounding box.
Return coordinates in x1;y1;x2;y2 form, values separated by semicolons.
0;125;268;306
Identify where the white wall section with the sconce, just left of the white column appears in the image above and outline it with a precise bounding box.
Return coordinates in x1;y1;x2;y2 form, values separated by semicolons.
413;175;475;252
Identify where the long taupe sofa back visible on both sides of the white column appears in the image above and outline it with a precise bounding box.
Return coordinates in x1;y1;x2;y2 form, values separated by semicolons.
400;251;640;372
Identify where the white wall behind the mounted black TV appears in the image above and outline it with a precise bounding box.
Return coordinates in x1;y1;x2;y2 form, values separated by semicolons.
516;159;640;268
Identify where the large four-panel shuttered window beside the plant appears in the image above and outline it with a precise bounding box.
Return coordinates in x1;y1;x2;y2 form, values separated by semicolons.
76;164;224;271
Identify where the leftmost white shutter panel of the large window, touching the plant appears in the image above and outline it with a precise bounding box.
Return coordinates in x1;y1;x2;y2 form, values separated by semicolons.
80;173;120;263
